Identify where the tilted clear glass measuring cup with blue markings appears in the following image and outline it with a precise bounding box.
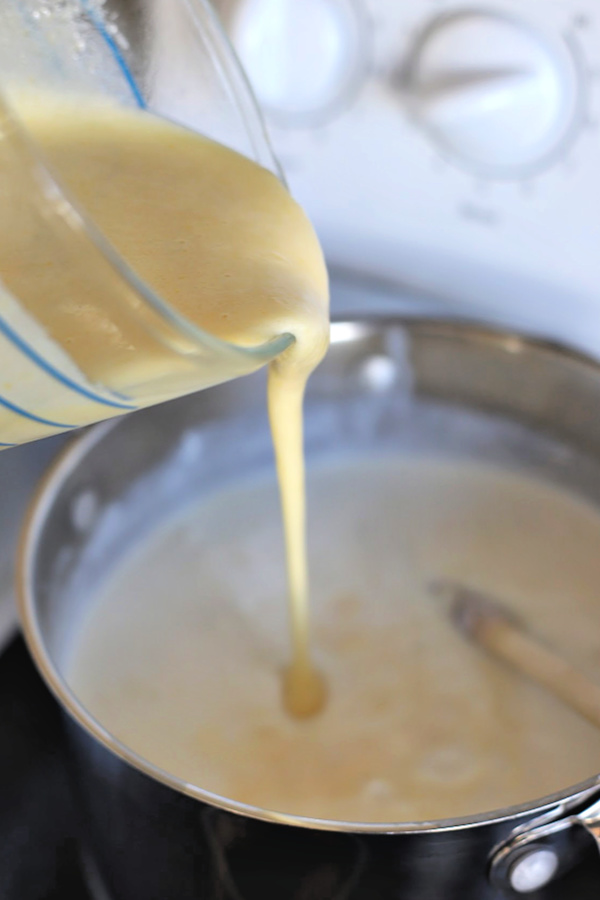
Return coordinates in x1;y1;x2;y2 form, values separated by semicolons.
0;0;293;447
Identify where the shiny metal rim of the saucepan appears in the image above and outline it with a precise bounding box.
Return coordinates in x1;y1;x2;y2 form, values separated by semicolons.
16;314;600;834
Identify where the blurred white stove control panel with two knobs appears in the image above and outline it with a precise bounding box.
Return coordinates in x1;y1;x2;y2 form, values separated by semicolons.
214;0;600;355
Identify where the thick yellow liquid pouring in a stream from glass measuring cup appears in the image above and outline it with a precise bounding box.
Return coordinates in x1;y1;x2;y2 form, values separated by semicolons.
0;98;329;716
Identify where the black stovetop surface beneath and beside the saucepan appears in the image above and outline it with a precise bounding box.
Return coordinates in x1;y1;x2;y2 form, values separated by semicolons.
0;638;600;900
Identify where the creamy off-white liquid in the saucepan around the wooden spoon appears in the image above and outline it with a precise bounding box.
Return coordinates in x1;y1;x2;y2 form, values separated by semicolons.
67;459;600;821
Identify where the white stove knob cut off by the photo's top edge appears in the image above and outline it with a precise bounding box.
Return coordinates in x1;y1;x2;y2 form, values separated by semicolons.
232;0;364;123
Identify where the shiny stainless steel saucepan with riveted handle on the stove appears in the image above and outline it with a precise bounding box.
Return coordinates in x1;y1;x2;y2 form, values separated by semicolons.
19;318;600;900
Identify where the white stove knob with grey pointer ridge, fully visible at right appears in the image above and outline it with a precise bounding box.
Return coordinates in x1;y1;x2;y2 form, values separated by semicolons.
405;11;577;176
